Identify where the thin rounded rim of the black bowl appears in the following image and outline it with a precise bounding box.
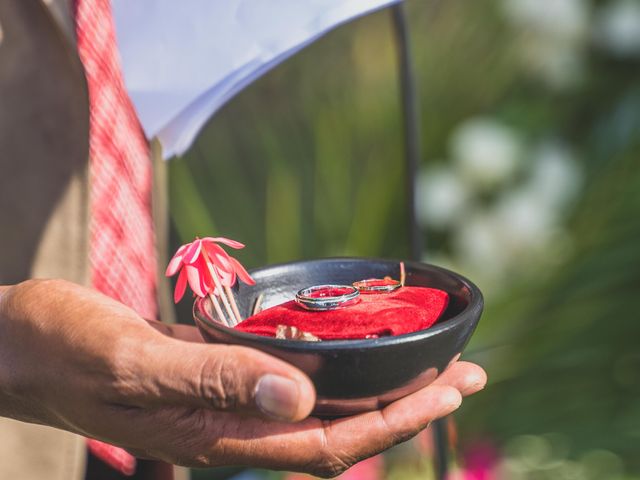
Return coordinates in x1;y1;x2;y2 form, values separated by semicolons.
192;257;484;352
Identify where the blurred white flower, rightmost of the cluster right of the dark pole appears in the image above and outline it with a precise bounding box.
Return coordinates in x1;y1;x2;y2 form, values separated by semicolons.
523;141;583;215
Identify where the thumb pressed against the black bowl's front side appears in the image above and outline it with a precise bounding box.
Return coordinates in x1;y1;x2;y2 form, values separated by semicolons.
136;339;316;421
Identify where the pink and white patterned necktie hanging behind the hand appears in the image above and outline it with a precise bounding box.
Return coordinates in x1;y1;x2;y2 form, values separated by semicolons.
75;0;157;475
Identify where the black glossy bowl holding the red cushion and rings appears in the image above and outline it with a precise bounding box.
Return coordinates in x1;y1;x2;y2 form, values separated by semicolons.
193;258;483;416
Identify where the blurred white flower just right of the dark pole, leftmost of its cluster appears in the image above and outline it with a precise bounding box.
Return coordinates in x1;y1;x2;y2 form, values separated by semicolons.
416;168;468;229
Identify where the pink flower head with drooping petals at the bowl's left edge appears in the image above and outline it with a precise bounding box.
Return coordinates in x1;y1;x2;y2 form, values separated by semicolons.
165;237;255;303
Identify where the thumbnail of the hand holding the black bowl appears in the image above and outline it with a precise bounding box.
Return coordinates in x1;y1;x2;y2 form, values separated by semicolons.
256;374;300;420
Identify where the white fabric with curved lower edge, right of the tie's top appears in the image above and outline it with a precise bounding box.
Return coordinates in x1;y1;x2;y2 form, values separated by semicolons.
112;0;399;158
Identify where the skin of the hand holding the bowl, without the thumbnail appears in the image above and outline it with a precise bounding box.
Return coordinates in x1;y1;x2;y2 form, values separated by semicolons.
0;280;486;477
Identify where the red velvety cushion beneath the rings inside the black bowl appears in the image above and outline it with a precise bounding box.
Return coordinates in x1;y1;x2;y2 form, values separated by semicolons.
236;287;449;340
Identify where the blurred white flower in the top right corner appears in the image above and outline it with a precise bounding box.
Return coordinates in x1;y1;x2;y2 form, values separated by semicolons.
594;0;640;57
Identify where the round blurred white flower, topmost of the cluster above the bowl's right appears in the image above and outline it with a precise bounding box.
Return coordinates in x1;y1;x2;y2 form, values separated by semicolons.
451;118;521;189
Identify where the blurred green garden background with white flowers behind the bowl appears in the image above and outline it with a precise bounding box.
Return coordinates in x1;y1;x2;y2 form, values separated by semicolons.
170;0;640;480
